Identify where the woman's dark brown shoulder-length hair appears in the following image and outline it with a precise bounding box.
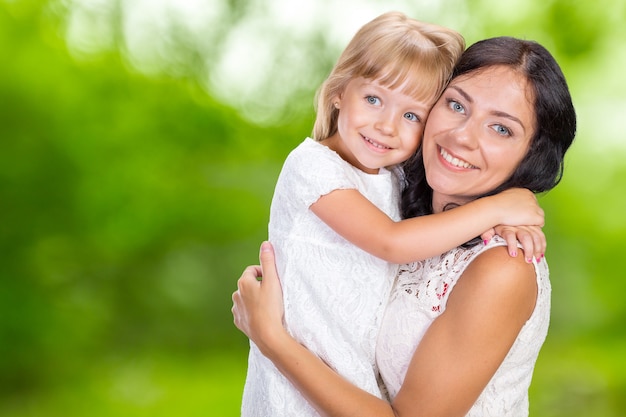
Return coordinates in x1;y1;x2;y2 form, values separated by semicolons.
402;37;576;218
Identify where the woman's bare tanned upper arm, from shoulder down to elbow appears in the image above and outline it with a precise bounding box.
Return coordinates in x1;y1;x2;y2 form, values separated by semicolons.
393;247;537;416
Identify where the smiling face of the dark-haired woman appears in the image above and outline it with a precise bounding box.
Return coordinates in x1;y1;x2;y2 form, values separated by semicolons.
422;66;535;212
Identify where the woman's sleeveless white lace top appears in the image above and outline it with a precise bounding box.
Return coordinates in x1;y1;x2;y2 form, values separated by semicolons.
376;236;551;417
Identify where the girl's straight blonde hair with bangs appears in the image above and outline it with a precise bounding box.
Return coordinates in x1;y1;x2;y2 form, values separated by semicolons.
313;12;465;141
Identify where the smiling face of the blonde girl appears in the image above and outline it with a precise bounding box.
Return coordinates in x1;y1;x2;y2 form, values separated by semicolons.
323;77;435;174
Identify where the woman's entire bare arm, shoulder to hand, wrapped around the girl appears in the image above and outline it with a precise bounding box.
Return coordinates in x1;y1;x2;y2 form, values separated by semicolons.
232;243;537;417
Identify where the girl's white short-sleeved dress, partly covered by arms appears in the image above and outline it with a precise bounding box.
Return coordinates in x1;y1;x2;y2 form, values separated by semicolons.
242;138;400;417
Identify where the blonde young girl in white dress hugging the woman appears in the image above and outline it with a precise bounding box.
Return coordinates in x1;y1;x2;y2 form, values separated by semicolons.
242;13;545;417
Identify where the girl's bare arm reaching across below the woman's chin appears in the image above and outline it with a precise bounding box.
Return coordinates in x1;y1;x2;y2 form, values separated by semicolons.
311;188;545;263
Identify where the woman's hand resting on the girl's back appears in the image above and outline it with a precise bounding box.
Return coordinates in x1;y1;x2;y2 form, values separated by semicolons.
231;242;285;352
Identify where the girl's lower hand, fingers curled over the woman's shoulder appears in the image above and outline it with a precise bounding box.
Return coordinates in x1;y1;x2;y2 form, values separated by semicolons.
481;225;546;262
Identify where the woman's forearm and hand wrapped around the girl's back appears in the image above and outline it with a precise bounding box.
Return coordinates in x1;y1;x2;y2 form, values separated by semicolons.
232;242;394;417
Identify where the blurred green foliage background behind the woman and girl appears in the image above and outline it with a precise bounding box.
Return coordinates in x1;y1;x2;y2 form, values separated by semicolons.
0;0;626;417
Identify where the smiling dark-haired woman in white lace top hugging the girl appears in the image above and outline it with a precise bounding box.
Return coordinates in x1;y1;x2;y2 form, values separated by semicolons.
233;37;576;416
